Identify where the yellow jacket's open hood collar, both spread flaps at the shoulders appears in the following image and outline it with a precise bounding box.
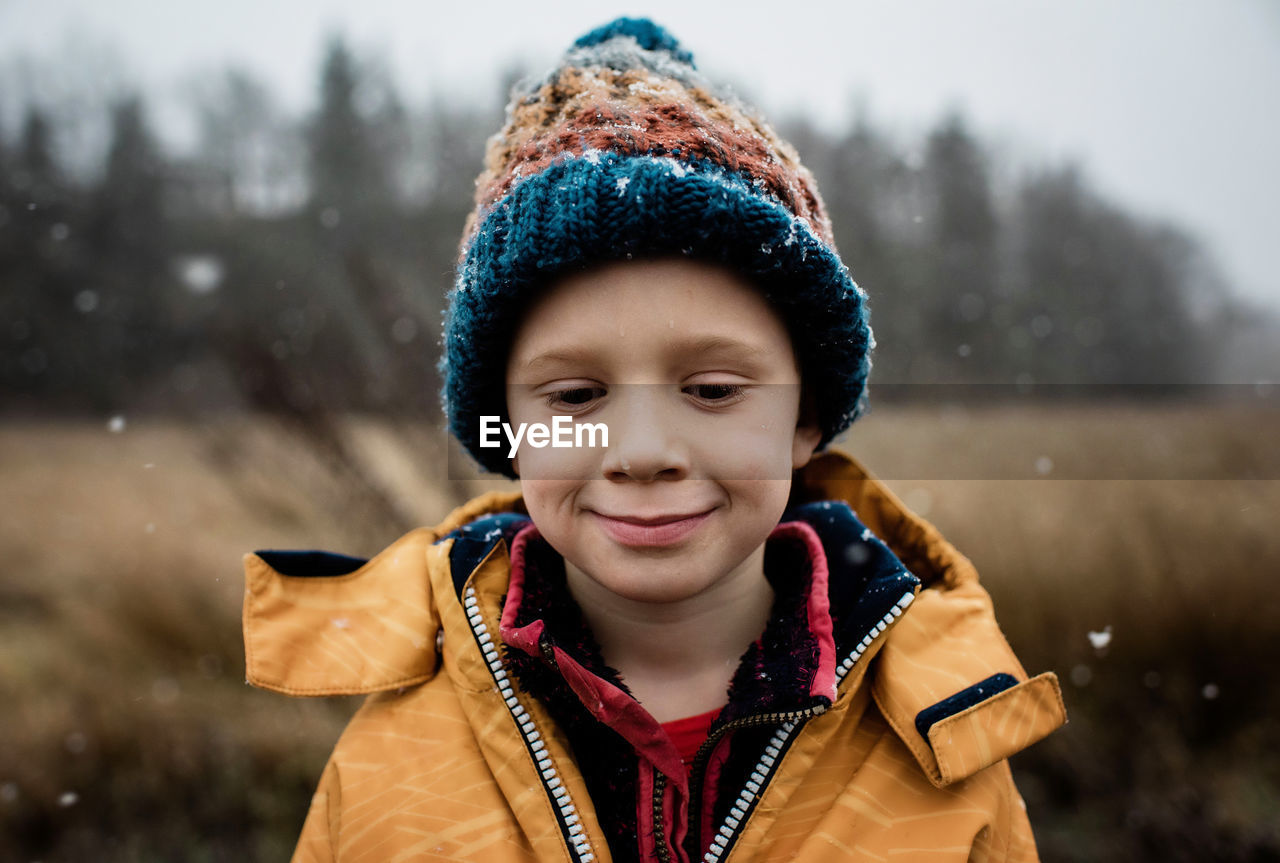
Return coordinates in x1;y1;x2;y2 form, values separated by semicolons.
244;451;1066;787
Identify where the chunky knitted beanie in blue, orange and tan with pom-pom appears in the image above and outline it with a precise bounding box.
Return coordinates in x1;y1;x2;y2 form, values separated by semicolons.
440;18;873;476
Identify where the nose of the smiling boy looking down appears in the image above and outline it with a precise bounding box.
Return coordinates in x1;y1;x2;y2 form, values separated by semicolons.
600;384;689;481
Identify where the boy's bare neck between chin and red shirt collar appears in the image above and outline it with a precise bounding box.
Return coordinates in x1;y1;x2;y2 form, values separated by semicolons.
564;545;773;722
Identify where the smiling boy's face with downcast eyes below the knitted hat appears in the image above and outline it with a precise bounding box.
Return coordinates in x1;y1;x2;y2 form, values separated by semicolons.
507;259;820;603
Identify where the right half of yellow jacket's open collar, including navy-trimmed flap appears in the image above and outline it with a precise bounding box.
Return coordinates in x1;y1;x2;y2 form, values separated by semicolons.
792;452;1066;787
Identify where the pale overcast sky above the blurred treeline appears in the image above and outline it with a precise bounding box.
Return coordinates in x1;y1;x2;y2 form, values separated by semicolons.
0;0;1280;306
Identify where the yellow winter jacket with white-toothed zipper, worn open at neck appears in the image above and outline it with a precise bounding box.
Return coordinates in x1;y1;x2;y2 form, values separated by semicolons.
244;452;1065;863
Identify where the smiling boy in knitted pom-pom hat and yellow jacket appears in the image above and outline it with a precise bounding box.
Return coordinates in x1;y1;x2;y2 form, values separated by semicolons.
244;19;1065;862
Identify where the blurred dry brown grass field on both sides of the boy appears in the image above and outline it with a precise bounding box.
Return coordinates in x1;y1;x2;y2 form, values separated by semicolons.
0;403;1280;863
